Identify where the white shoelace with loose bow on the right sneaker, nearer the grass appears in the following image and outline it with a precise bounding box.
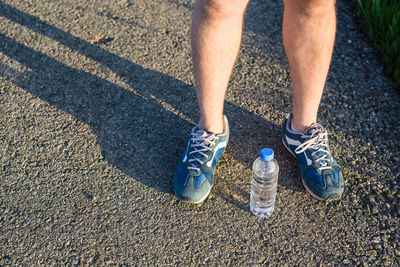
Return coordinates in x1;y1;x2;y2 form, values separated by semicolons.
295;126;332;171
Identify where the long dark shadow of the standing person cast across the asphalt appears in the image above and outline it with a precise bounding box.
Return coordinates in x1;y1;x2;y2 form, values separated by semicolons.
0;3;303;209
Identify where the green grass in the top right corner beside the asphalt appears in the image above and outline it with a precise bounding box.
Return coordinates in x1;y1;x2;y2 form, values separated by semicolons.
357;0;400;86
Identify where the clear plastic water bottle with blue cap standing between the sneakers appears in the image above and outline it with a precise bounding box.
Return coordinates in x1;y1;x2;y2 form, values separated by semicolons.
250;148;279;217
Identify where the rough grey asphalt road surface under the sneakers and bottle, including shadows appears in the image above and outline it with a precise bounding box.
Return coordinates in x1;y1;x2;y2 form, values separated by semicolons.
0;0;400;266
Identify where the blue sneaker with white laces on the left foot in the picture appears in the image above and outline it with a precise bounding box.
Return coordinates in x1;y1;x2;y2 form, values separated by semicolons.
174;116;229;203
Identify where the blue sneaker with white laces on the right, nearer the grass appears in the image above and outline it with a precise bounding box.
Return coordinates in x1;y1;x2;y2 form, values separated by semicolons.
282;113;344;200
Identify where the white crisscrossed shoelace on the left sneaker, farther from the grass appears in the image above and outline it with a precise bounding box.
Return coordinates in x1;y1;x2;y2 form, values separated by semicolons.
188;130;218;171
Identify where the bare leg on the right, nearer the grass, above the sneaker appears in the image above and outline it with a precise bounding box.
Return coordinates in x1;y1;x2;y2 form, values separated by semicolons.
283;0;336;130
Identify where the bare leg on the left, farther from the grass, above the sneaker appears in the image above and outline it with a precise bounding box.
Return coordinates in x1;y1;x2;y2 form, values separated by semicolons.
192;0;247;133
